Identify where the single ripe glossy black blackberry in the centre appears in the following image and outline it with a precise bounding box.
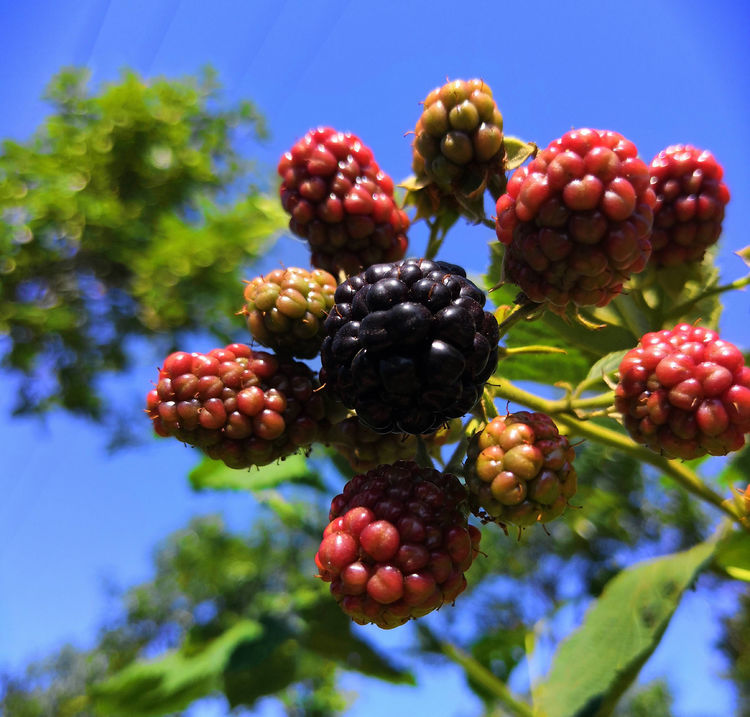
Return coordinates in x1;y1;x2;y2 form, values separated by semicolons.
321;259;499;434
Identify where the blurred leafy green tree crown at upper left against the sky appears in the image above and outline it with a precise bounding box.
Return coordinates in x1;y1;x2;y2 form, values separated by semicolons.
0;70;286;417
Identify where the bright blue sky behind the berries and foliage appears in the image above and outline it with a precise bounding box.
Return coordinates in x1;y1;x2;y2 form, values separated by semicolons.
0;0;750;717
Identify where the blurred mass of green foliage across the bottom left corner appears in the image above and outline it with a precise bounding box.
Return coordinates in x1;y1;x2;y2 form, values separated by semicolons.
0;508;413;717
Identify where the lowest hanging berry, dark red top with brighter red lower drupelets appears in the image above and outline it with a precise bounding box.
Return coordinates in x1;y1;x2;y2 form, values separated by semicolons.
315;461;481;629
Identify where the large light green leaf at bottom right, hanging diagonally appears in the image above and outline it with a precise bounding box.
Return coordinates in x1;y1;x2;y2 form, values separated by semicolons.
536;542;716;717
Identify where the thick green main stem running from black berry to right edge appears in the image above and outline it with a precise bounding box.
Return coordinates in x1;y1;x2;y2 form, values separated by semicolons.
494;380;746;527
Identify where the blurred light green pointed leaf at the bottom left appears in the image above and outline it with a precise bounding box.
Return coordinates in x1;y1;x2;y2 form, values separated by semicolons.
91;620;263;717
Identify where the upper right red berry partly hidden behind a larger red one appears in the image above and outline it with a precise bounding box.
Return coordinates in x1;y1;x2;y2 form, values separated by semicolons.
649;144;729;266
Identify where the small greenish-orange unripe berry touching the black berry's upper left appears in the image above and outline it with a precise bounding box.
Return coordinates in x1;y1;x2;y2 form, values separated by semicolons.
242;267;336;358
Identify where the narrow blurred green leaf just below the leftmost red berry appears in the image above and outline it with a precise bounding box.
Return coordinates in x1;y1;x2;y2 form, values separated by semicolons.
188;455;324;491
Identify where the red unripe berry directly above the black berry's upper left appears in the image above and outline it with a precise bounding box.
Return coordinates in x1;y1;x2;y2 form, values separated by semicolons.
278;127;409;274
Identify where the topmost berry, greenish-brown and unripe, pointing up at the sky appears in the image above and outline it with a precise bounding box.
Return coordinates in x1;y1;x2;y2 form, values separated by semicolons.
412;79;505;214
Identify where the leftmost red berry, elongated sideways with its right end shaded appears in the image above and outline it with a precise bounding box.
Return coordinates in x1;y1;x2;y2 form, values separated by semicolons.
146;344;325;468
